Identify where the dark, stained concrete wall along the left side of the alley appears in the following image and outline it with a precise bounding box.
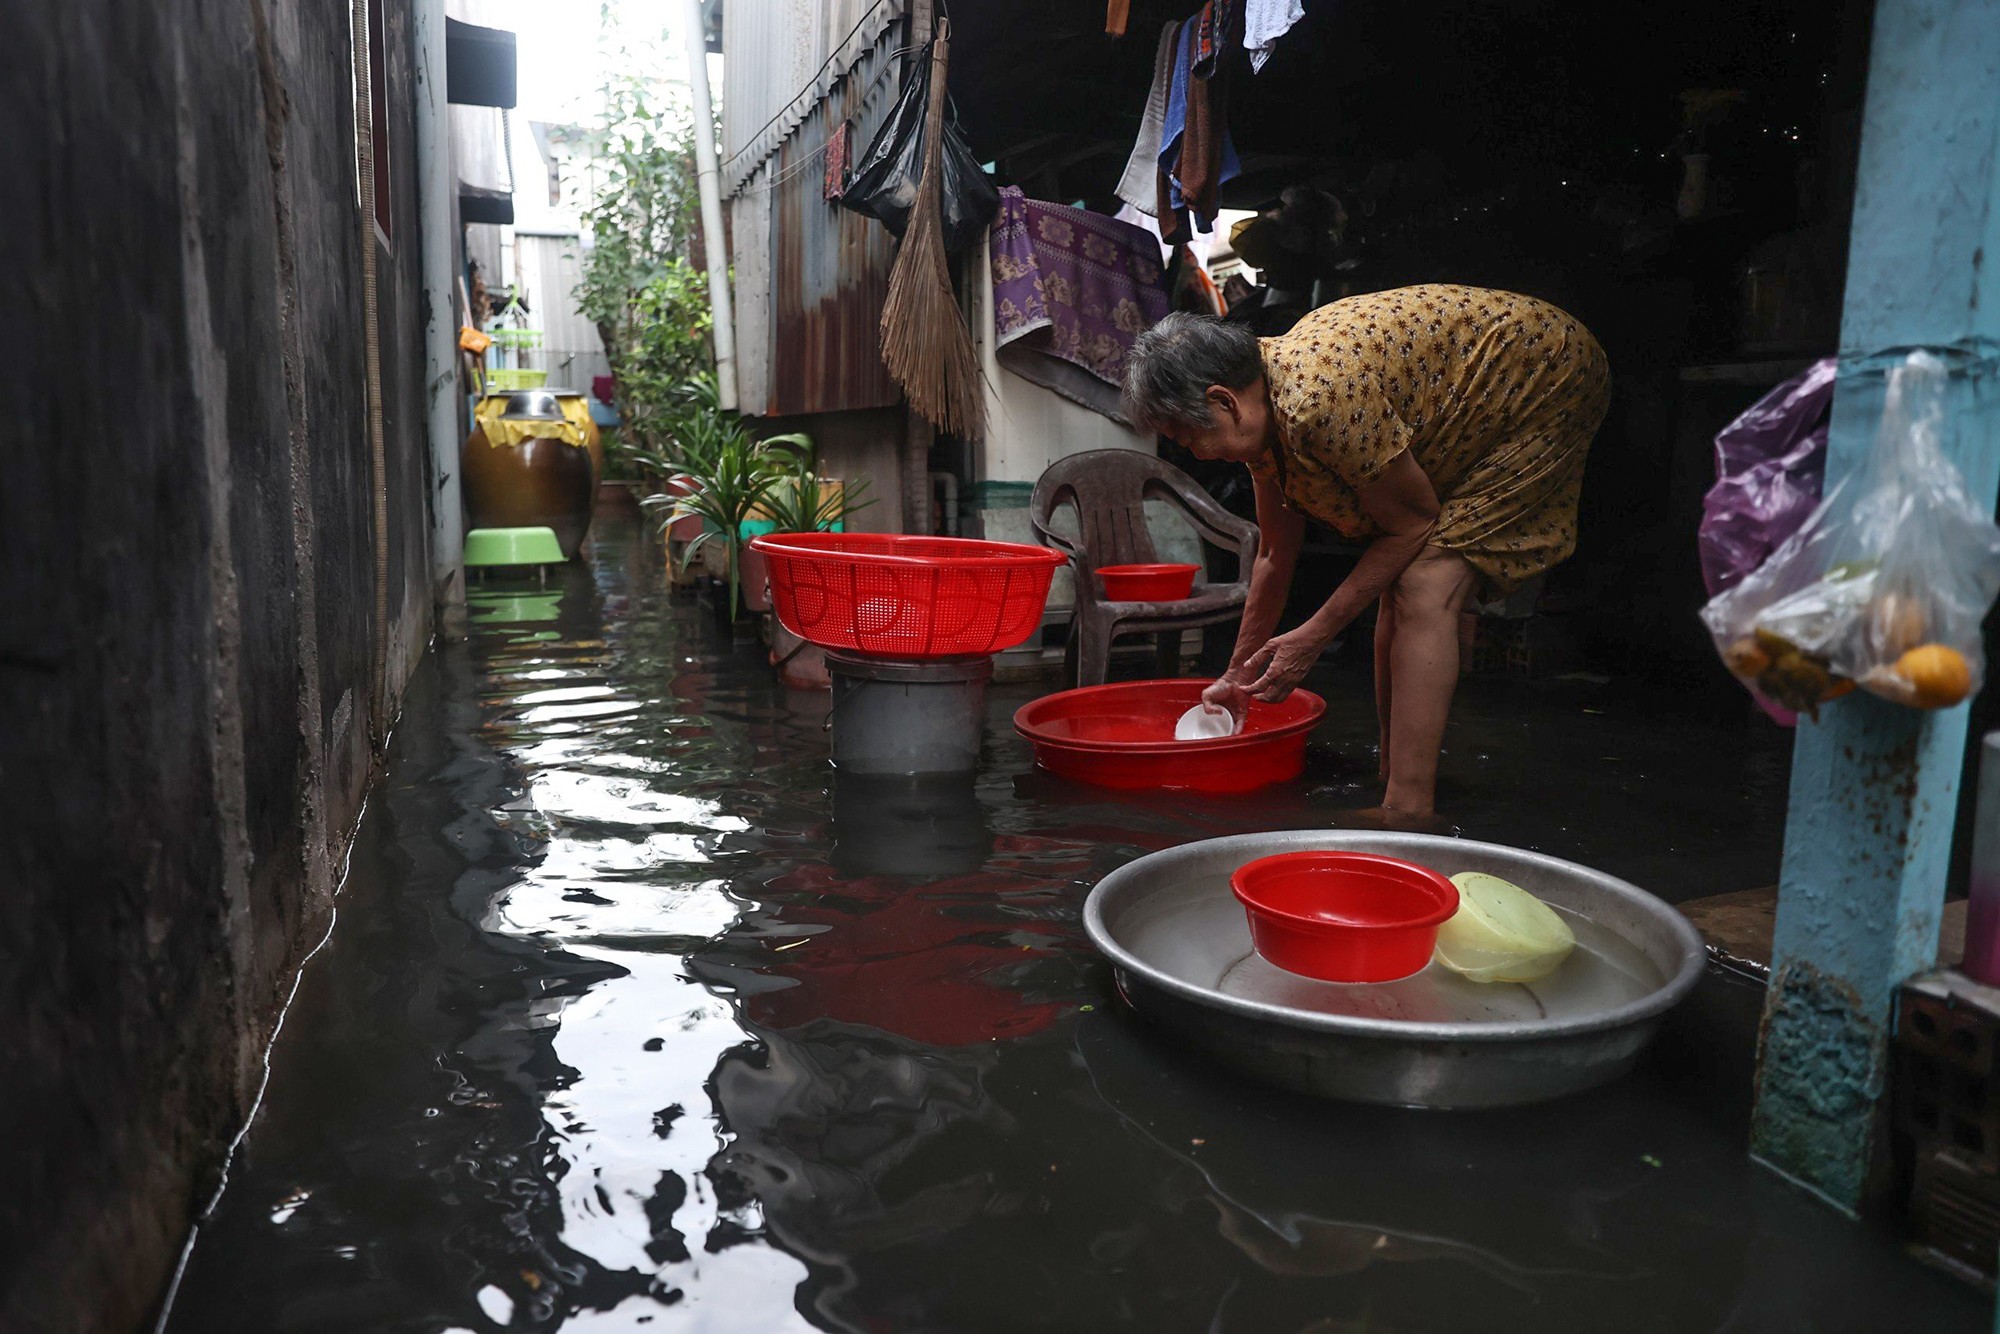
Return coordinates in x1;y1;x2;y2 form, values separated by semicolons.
0;0;428;1334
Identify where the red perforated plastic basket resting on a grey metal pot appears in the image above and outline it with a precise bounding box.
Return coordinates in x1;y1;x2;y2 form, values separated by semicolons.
750;532;1068;658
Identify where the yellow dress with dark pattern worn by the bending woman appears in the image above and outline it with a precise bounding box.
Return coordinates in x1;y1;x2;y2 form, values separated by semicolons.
1250;284;1610;594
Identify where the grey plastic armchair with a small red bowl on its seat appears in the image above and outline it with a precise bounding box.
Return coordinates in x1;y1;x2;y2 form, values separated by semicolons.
1028;450;1258;686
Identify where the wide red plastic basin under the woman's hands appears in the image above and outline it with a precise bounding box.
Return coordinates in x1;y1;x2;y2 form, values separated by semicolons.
1014;680;1326;792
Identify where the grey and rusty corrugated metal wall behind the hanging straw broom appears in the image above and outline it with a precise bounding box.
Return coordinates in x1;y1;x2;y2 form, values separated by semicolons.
724;0;906;416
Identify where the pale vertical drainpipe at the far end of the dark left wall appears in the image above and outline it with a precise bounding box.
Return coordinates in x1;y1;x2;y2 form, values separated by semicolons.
412;0;466;638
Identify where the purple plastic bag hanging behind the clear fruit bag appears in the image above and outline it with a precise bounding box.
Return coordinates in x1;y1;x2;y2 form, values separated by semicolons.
1696;358;1836;598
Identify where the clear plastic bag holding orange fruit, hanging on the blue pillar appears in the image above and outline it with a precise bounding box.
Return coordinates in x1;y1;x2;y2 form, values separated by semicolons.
1702;352;2000;716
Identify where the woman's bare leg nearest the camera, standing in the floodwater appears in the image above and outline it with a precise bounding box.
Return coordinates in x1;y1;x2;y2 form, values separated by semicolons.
1382;546;1478;818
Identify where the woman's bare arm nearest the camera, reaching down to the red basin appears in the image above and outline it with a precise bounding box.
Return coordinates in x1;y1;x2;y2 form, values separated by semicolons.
1230;450;1438;702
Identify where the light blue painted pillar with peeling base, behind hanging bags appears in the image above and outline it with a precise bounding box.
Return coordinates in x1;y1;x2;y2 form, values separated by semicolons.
1752;0;2000;1212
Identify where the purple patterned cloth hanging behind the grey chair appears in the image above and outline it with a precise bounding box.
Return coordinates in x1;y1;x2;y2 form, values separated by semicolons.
992;186;1168;416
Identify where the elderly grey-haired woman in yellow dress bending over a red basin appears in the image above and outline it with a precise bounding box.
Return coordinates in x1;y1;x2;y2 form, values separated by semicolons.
1124;286;1610;826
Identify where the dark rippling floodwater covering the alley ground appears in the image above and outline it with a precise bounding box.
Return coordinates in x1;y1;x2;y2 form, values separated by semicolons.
166;526;1990;1334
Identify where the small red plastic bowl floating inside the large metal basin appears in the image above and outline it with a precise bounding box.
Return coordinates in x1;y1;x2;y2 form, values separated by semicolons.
1230;852;1458;982
